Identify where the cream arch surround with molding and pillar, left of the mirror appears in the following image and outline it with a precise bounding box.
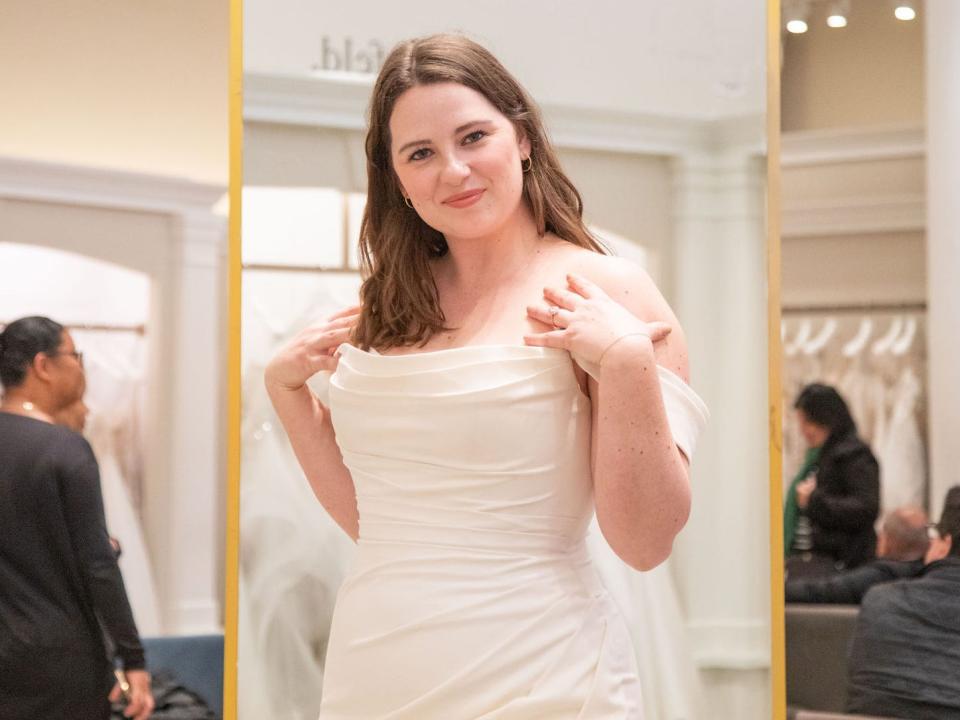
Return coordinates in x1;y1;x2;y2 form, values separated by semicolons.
0;158;226;634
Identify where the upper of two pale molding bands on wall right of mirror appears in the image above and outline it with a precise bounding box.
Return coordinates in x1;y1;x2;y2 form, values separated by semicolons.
780;125;926;168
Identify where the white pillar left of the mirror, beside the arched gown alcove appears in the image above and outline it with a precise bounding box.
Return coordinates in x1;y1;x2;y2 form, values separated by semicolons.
163;212;226;634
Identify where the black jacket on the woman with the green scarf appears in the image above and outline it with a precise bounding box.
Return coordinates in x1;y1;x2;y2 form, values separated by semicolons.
806;432;880;569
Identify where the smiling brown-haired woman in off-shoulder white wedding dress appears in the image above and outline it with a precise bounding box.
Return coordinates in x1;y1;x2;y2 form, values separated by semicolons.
265;35;705;719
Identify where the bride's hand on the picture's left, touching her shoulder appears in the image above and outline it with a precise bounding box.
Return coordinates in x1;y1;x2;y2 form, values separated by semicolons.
264;305;360;390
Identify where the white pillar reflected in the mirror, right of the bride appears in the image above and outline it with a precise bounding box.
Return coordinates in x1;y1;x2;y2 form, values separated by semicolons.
673;152;770;717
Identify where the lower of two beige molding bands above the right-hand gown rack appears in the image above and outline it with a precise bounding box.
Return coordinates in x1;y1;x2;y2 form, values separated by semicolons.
781;193;927;238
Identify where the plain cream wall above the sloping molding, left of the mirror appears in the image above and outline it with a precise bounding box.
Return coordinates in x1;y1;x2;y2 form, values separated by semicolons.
0;0;229;185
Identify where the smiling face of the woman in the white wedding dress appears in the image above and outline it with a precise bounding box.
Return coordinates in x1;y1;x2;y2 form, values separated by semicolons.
390;83;530;240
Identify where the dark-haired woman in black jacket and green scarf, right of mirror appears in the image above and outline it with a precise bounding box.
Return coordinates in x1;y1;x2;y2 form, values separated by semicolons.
784;383;880;577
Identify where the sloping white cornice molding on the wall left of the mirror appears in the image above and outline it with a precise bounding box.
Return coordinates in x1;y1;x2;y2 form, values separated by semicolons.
0;157;227;215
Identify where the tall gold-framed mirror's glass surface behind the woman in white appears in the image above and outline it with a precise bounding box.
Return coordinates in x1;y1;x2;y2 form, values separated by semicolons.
238;0;770;720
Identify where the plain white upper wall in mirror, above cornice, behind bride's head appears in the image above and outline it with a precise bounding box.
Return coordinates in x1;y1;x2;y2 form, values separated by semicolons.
244;0;766;119
